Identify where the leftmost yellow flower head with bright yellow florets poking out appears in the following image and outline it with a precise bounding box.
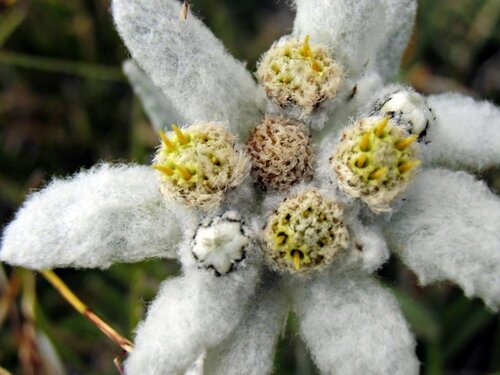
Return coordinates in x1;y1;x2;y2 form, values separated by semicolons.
153;123;248;208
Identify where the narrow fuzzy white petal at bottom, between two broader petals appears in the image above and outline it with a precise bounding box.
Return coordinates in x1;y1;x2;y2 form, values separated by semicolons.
205;274;288;375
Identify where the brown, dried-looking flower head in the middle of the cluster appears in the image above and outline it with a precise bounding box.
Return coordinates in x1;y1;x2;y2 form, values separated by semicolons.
247;117;314;191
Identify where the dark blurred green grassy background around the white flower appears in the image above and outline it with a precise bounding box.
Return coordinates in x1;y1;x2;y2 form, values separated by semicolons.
0;0;500;375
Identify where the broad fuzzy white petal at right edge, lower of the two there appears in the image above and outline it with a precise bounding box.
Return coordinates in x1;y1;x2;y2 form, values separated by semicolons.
386;169;500;309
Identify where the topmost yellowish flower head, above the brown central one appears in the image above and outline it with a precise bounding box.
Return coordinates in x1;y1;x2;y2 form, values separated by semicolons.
256;36;344;113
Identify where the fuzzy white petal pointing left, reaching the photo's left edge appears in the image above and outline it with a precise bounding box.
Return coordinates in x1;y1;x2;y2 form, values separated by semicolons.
0;164;192;269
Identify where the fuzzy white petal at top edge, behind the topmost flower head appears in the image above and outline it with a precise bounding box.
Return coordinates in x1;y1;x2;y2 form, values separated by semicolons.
294;0;416;78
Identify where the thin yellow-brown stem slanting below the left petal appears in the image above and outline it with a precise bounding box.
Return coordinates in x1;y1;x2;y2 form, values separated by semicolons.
40;270;134;353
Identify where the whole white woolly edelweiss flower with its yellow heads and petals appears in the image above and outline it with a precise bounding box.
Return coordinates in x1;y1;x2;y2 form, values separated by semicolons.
0;0;500;375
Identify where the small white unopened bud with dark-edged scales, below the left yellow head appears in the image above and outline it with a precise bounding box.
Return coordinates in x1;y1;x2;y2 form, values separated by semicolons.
192;211;251;276
